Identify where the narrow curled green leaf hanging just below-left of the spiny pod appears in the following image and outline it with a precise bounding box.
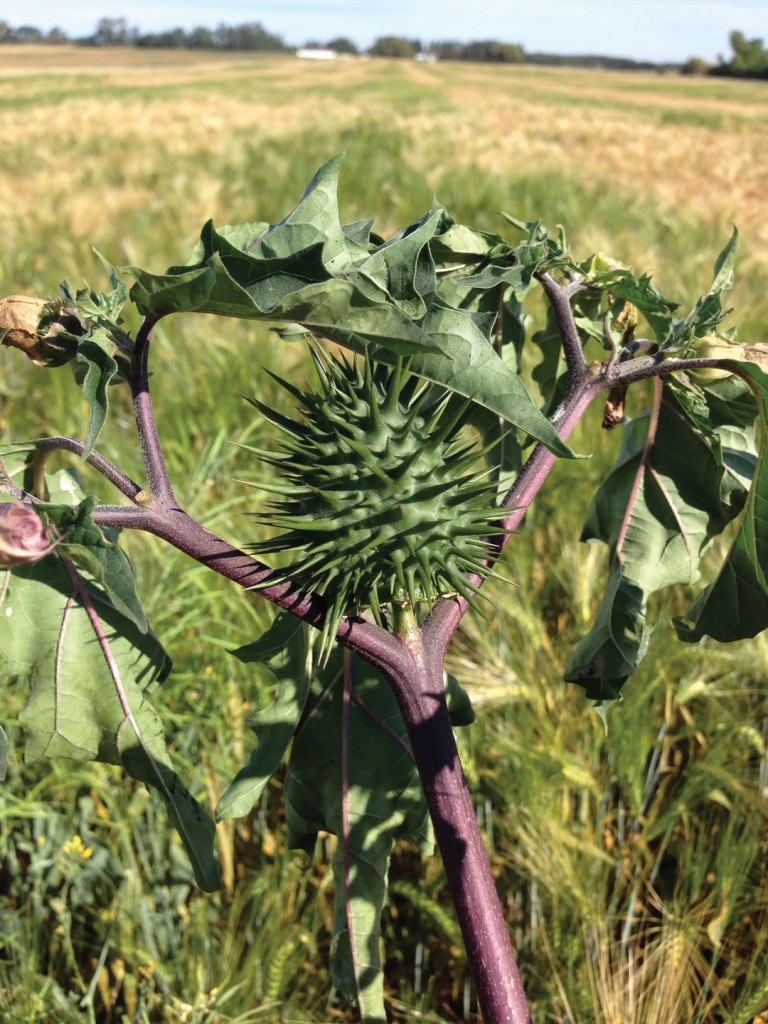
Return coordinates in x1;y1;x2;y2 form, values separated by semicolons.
216;612;311;821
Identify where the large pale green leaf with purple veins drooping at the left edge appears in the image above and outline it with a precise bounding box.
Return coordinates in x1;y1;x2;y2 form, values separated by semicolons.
0;555;219;890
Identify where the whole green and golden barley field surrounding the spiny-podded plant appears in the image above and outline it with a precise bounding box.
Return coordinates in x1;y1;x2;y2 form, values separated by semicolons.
0;46;768;1024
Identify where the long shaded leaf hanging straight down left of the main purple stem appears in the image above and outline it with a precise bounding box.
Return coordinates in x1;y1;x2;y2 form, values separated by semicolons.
285;651;431;1024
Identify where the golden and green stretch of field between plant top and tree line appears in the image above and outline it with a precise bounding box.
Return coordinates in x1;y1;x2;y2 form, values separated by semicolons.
0;46;768;288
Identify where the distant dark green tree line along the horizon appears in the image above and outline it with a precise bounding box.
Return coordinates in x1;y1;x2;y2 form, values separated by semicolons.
0;17;768;79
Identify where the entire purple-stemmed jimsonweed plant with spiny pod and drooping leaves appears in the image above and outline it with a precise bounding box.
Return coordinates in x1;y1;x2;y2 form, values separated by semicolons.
0;159;768;1024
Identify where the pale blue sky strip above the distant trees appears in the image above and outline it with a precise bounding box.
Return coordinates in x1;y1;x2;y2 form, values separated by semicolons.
12;0;768;61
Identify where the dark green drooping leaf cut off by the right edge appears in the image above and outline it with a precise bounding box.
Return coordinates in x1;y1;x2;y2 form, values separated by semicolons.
675;360;768;643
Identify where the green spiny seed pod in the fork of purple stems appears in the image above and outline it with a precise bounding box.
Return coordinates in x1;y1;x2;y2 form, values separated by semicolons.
249;349;503;650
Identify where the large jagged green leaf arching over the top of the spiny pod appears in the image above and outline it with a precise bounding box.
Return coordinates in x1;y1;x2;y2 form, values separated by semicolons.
128;158;571;456
